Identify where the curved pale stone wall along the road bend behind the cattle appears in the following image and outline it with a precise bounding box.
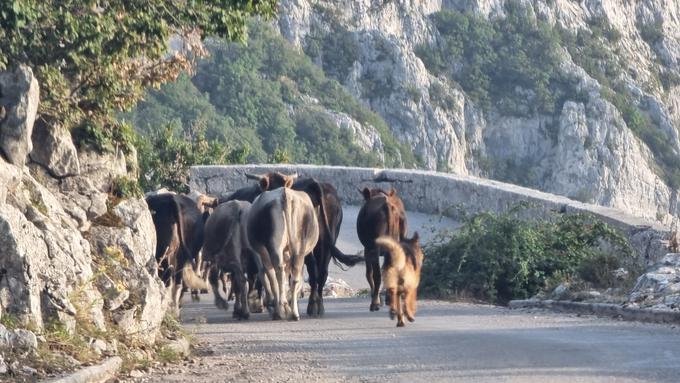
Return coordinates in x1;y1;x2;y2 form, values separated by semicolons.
190;165;668;264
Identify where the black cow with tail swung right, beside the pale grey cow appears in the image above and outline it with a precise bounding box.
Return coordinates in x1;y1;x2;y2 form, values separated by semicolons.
293;178;364;317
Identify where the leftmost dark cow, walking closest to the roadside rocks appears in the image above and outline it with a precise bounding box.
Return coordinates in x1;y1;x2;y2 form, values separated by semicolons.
146;193;207;313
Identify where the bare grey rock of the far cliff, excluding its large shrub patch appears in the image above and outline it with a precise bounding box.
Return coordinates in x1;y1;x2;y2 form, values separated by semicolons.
278;0;680;223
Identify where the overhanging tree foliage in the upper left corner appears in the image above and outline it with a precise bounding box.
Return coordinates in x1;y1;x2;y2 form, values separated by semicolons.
0;0;276;150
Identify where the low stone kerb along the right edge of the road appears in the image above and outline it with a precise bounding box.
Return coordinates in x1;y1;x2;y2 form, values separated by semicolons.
508;299;680;324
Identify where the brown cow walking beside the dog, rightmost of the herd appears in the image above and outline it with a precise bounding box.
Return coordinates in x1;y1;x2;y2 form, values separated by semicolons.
357;188;407;311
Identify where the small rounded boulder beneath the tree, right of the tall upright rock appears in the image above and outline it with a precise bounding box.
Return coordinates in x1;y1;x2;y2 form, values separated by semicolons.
31;121;80;178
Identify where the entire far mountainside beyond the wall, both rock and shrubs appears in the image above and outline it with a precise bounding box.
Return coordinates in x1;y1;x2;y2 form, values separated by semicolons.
278;0;680;222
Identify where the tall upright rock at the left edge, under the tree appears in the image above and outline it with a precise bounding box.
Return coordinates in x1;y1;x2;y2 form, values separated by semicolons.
0;65;40;167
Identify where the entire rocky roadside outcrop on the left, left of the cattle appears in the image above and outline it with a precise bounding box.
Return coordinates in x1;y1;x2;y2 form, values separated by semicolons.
0;67;167;380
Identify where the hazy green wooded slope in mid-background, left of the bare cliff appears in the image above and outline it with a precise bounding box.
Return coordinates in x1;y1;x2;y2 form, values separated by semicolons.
132;20;416;171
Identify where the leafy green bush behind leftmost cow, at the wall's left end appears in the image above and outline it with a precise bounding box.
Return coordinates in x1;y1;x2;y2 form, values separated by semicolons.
137;124;249;192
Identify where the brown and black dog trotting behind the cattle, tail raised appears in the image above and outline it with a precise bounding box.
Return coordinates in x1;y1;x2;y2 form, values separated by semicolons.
375;232;424;327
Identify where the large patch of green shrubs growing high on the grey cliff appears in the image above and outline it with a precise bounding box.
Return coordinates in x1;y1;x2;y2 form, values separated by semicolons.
416;2;573;114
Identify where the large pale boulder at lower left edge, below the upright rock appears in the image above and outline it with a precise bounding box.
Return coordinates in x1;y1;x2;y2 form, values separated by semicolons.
0;174;104;329
